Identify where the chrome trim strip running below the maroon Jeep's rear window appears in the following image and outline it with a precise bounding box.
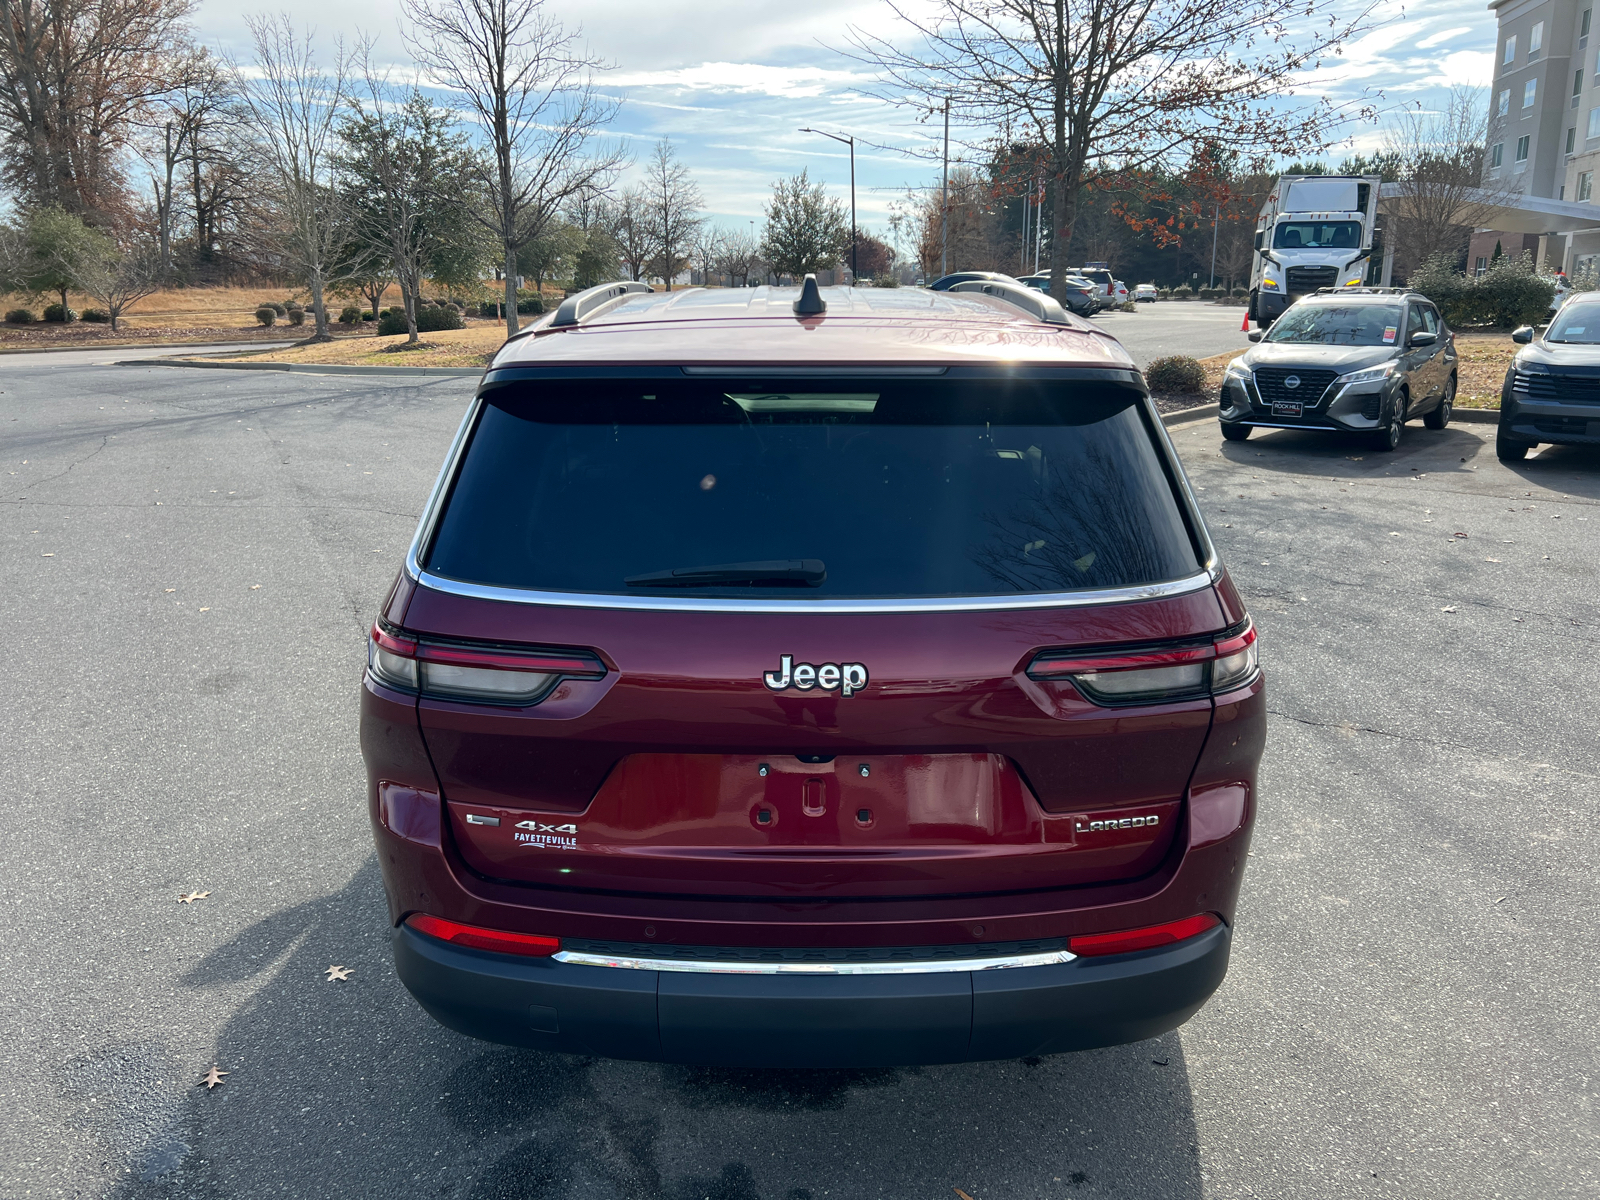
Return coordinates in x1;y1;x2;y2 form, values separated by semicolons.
406;569;1219;616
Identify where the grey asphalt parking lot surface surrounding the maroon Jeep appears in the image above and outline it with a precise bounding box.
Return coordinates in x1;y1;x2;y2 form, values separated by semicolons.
0;352;1600;1200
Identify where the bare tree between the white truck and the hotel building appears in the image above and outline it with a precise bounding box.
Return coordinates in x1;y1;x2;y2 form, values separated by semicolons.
1382;86;1510;277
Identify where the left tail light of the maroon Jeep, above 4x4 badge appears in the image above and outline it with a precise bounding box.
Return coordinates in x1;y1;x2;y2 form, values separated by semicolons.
366;624;605;706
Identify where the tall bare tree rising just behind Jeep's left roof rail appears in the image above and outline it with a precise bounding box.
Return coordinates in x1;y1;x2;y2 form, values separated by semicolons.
403;0;622;333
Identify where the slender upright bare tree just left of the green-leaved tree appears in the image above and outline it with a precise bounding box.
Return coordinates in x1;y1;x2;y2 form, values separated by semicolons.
234;14;350;341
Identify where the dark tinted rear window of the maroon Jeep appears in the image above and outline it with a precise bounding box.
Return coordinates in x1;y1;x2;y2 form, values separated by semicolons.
427;379;1200;602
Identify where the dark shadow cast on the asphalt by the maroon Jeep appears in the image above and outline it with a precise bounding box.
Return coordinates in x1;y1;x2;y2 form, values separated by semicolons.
115;859;1202;1200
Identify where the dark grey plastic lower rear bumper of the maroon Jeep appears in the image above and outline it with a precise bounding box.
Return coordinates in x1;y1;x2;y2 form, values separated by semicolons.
395;925;1232;1067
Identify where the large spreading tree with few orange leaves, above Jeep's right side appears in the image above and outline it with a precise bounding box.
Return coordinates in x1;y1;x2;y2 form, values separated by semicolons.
850;0;1376;299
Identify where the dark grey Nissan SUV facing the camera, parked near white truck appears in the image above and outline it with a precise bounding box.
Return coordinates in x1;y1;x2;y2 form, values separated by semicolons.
1218;288;1456;450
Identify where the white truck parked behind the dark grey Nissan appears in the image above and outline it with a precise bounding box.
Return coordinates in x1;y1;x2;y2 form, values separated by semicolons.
1250;174;1382;328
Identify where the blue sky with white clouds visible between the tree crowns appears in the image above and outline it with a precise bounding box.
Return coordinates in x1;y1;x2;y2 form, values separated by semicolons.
197;0;1494;244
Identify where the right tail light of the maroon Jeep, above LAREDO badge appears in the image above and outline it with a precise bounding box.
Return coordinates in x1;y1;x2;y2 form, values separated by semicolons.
1027;618;1258;707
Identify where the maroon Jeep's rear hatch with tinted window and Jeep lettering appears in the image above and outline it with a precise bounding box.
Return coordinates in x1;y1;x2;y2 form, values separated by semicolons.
389;371;1222;899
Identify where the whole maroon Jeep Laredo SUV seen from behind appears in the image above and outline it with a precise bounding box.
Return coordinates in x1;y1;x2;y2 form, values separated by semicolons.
362;278;1266;1067
